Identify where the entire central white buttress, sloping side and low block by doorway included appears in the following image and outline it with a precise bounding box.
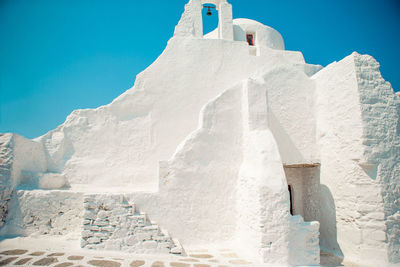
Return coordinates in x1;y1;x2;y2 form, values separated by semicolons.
133;77;319;265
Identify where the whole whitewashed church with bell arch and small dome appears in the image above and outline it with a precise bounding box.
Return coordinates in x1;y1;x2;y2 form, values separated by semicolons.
0;0;400;267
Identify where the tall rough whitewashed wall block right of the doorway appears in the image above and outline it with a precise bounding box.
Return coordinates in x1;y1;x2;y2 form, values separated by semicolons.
313;53;400;266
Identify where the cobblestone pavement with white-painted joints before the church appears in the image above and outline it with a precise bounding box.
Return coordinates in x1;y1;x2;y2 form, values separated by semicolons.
0;248;257;267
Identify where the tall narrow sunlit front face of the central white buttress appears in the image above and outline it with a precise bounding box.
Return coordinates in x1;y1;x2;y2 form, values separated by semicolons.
237;80;290;265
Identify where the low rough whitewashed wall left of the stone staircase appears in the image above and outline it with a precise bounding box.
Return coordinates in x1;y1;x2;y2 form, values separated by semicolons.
0;190;83;239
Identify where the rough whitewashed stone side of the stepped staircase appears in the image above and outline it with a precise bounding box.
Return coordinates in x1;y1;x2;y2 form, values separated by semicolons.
81;194;183;254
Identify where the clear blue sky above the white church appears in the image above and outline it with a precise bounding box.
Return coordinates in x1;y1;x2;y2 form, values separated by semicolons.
0;0;400;138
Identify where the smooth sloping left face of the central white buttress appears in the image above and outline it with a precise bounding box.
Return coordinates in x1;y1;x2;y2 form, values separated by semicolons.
133;84;242;247
